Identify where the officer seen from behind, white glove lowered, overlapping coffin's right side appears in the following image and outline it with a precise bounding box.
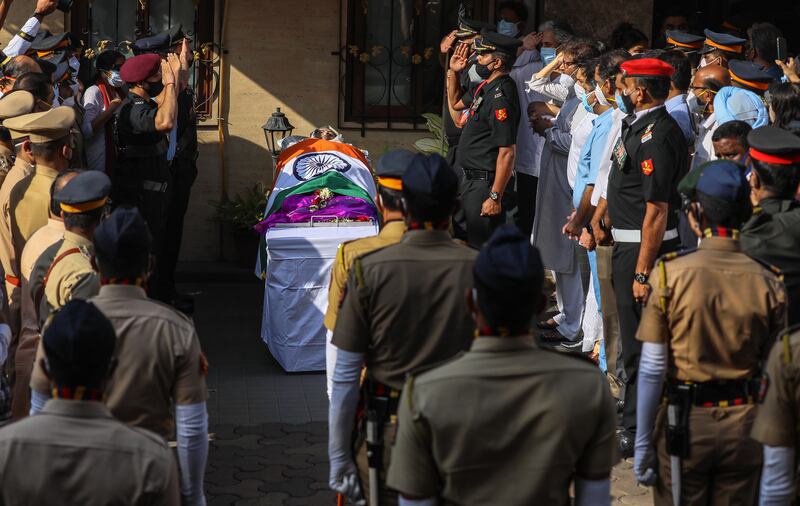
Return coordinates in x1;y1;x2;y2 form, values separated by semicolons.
328;154;476;506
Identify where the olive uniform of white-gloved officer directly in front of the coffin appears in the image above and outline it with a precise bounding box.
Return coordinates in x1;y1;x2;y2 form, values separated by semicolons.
332;230;477;506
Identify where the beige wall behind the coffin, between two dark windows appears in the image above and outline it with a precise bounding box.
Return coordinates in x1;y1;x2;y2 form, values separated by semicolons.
190;0;422;260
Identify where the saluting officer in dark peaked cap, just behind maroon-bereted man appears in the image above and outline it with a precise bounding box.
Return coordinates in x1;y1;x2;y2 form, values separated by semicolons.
133;25;198;312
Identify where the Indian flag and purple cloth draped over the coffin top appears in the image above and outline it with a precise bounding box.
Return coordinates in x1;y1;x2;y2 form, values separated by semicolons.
255;139;378;279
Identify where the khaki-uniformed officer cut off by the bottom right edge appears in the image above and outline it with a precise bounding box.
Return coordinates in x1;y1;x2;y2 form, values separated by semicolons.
750;325;800;506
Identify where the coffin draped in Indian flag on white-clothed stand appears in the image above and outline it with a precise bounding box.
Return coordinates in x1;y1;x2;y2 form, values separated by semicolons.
256;139;378;372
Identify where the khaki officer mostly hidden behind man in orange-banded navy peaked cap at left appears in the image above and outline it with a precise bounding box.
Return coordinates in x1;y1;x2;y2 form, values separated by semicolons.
11;170;78;419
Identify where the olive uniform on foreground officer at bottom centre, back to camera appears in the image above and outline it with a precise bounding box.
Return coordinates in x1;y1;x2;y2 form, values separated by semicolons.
388;336;617;505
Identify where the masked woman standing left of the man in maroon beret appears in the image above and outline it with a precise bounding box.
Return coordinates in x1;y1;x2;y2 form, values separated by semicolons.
83;49;125;172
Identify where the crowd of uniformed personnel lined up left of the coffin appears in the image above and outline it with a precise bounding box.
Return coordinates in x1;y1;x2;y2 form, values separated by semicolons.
0;0;208;505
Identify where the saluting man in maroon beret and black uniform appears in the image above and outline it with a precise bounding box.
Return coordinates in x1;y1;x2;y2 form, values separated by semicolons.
112;54;180;301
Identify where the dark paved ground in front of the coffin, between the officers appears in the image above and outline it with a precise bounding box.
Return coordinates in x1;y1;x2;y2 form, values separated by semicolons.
189;271;652;506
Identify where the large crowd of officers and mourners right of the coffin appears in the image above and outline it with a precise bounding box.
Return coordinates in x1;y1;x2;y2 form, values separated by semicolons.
325;1;800;506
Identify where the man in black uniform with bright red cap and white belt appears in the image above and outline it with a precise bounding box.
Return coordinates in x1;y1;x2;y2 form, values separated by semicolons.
606;58;689;457
